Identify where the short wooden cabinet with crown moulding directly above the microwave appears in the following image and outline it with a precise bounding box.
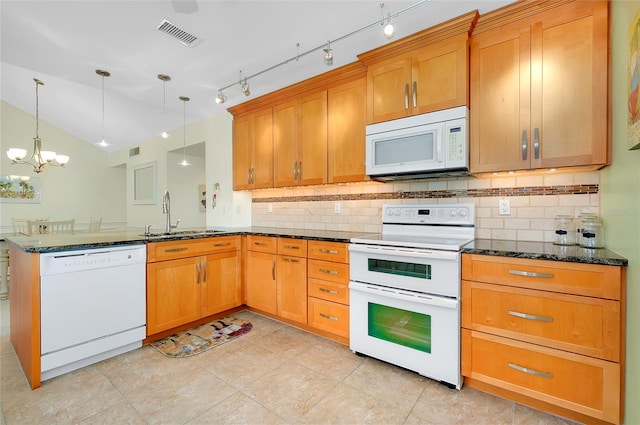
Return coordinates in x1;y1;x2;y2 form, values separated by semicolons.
358;11;478;124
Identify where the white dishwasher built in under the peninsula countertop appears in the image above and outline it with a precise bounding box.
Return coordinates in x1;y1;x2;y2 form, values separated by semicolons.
40;245;147;381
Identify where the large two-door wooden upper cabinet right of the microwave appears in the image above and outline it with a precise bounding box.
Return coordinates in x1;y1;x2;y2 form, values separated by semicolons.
470;1;610;173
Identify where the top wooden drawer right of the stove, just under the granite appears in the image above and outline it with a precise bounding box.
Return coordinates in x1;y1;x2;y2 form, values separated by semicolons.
462;254;622;300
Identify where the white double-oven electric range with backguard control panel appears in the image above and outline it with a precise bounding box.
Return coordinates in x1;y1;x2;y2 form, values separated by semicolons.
349;204;475;389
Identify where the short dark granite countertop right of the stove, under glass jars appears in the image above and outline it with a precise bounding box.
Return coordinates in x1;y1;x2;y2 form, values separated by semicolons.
462;239;629;266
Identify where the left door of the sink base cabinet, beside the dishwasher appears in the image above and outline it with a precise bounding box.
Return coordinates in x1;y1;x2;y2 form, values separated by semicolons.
147;257;201;335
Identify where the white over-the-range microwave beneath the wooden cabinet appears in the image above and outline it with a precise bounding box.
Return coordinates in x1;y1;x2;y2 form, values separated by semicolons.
366;106;469;181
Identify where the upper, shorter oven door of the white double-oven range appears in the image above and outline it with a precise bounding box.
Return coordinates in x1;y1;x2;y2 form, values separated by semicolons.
349;244;460;298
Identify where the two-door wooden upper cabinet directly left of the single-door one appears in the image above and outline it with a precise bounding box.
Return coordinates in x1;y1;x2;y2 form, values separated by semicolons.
273;90;327;187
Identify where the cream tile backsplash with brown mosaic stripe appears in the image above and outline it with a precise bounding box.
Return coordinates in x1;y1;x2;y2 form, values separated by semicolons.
252;171;600;242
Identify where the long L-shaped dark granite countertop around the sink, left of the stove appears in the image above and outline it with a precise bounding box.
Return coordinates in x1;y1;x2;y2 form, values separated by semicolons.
4;227;363;253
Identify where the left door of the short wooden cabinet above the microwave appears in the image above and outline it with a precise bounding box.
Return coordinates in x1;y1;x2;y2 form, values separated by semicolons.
367;55;411;124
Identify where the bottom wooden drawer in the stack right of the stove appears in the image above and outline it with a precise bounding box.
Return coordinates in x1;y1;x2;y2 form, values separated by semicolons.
462;329;621;423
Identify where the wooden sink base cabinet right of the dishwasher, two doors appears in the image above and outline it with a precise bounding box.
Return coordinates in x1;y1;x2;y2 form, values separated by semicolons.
147;236;242;336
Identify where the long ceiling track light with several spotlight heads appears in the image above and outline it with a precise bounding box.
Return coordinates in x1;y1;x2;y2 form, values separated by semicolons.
216;0;430;104
